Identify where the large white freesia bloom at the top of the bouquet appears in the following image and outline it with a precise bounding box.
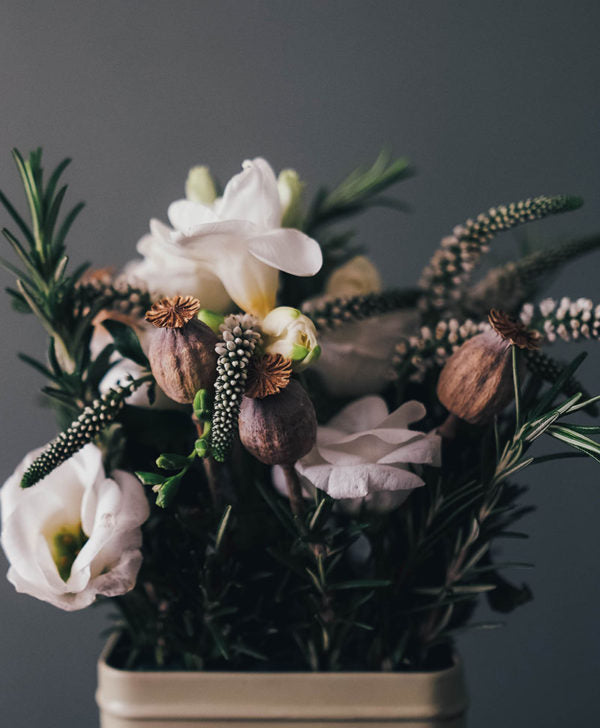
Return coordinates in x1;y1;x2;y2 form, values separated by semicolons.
126;158;323;318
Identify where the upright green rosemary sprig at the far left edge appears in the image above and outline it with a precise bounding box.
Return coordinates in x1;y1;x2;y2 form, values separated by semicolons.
0;149;145;422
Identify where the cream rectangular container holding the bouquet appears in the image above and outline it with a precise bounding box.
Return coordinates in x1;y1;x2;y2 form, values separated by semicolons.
96;642;467;728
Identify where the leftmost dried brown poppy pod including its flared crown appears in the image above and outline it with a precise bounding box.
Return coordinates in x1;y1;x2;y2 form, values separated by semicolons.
146;296;217;404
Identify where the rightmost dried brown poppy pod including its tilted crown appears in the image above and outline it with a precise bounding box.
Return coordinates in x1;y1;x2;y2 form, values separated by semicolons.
437;310;540;425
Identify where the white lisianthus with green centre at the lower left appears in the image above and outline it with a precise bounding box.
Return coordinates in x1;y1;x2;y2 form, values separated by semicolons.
0;444;149;611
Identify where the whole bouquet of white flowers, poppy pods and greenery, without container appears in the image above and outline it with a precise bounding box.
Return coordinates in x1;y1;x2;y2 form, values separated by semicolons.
0;150;600;671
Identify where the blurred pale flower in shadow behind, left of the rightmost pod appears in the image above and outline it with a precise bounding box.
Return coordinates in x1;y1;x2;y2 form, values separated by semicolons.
314;309;419;397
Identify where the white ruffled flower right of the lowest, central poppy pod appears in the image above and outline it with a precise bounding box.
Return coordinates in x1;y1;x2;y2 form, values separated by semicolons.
296;396;441;509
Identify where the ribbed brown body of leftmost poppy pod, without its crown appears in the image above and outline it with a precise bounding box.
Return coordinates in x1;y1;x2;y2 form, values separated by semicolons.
148;320;217;404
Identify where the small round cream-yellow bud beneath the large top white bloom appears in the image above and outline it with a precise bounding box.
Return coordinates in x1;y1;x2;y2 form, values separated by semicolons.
261;306;321;371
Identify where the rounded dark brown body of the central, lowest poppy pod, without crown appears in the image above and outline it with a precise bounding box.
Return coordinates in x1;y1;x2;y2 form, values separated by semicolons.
239;380;317;465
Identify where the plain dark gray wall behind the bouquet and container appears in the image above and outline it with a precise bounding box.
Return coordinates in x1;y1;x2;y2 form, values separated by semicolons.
0;0;600;728
